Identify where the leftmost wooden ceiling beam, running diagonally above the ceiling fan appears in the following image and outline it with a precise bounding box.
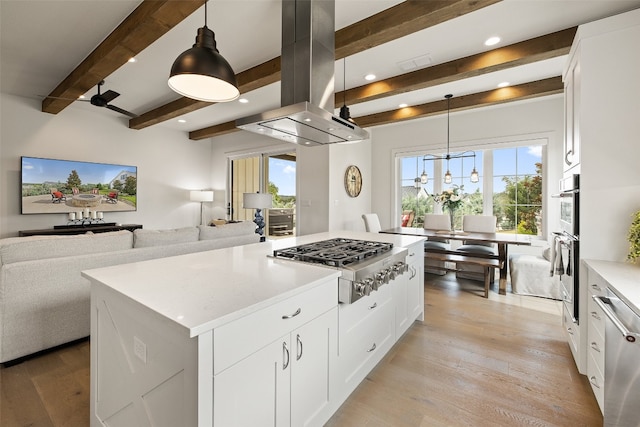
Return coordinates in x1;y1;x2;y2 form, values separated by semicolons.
42;0;204;114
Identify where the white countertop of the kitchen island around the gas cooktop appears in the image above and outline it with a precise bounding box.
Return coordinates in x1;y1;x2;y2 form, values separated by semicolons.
82;231;424;337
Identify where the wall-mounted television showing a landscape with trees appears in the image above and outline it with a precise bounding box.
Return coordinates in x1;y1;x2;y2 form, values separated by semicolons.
20;156;138;214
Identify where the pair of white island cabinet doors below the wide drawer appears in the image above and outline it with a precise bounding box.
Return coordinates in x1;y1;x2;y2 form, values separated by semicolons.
213;308;337;426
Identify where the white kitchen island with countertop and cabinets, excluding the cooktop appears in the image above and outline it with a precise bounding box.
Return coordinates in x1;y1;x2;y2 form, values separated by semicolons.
83;232;424;427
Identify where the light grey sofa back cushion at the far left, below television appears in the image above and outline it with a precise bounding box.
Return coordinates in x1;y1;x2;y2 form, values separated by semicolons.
0;230;133;264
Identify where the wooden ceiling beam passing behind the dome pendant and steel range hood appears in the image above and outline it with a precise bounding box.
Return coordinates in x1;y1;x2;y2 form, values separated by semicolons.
129;0;502;129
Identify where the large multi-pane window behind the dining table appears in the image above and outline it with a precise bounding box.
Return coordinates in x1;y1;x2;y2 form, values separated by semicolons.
400;143;543;235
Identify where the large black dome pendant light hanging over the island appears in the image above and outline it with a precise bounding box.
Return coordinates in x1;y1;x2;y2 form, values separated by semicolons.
169;1;240;102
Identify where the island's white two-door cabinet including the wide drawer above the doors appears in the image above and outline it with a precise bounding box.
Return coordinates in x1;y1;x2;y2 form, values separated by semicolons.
212;280;338;426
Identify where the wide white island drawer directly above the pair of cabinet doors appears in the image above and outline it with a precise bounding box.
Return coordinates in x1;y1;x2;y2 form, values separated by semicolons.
213;279;338;375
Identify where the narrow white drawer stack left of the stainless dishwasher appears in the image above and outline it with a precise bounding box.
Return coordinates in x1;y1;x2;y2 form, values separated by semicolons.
587;269;607;411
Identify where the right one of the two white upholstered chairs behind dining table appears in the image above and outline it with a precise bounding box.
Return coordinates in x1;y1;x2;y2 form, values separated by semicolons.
456;215;498;283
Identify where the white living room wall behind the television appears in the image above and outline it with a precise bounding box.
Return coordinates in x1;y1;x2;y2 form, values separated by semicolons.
0;93;212;237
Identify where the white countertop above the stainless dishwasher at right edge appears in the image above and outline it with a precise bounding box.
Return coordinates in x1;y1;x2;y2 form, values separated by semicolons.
584;259;640;316
